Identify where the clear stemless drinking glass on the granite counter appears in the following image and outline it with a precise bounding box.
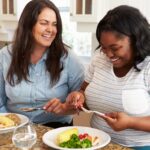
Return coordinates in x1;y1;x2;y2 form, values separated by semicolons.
12;123;37;150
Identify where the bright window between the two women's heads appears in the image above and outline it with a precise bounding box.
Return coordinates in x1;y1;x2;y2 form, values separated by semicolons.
52;0;92;59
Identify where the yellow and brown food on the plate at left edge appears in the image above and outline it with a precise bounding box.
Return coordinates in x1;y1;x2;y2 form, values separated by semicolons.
0;113;21;128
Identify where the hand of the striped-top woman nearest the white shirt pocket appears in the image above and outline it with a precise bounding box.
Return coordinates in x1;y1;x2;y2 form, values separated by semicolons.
101;112;132;131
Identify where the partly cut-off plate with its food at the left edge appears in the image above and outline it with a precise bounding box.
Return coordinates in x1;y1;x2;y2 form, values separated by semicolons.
0;113;29;133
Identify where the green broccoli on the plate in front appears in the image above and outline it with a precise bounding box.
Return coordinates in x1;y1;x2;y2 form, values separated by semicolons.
59;134;92;148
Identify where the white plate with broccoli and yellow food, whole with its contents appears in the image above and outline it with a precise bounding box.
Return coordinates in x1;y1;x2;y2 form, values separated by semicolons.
42;126;111;150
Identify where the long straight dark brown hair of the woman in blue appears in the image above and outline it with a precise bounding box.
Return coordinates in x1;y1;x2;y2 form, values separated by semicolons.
7;0;68;86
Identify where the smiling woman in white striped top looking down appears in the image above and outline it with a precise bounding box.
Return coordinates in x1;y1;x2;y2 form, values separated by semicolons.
67;5;150;150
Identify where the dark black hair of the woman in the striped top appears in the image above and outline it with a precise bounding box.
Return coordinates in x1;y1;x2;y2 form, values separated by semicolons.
96;5;150;70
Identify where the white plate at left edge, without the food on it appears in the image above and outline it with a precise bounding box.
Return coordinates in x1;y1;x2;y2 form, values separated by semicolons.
0;113;29;133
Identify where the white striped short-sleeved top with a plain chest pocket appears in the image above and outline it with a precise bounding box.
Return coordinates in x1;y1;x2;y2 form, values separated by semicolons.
85;51;150;147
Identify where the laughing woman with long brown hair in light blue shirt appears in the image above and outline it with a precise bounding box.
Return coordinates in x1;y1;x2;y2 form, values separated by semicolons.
0;0;84;128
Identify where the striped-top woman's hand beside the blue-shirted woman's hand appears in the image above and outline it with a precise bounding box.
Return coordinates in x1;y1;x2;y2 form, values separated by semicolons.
66;91;85;109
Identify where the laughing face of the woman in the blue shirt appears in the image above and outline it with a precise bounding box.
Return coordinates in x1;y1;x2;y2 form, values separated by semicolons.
32;8;57;48
